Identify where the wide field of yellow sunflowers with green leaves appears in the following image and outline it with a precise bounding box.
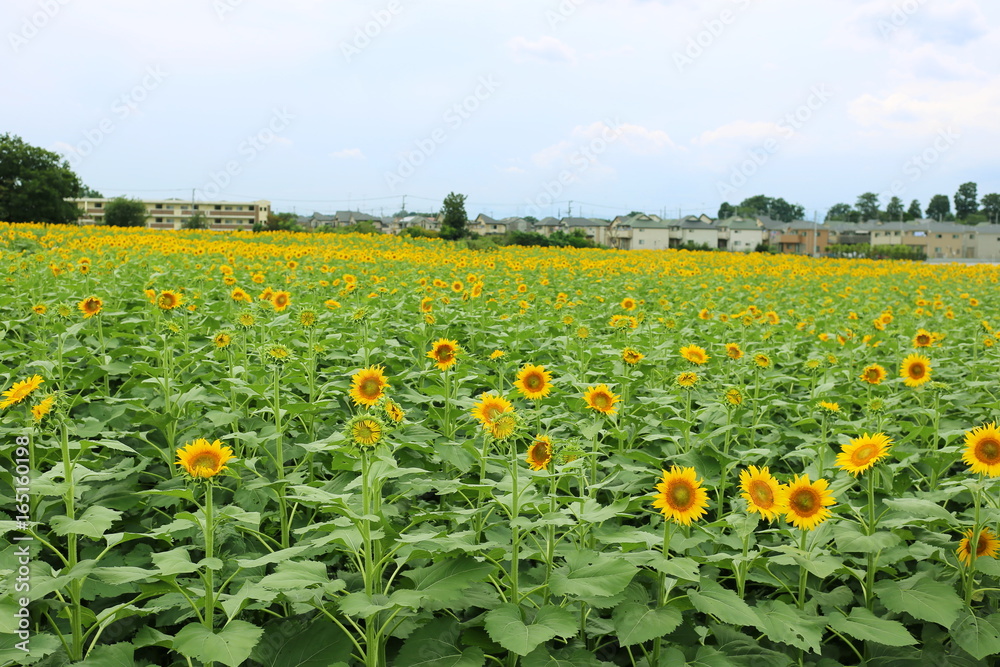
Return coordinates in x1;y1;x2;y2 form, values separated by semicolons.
0;224;1000;667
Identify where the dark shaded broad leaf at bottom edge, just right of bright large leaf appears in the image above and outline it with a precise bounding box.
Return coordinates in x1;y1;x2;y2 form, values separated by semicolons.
250;618;353;667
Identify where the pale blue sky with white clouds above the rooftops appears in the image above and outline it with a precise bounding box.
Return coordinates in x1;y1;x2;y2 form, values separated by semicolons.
0;0;1000;220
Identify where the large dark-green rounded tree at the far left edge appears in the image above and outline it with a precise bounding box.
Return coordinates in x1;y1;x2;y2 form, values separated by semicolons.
0;134;82;224
